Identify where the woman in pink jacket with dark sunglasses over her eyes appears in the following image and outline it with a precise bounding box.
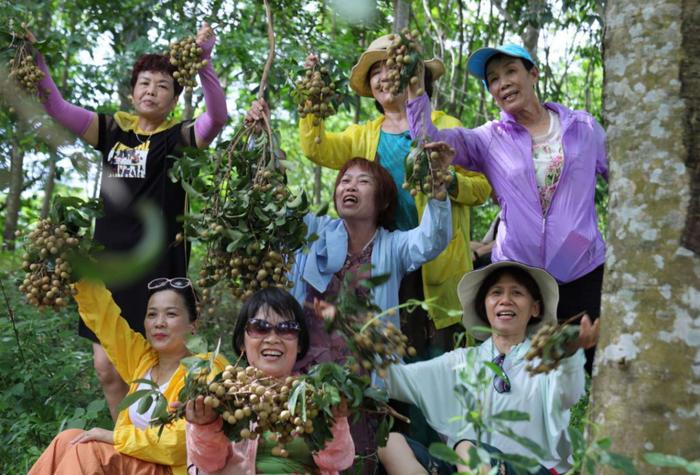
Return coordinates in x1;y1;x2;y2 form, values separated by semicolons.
186;288;355;475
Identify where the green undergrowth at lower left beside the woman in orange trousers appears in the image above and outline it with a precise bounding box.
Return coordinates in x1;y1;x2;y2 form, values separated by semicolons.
0;260;112;473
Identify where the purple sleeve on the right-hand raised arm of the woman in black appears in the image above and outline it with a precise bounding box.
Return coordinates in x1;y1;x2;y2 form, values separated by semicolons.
194;38;228;144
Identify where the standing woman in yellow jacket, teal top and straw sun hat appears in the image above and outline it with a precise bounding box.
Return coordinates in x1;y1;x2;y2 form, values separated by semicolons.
299;35;491;351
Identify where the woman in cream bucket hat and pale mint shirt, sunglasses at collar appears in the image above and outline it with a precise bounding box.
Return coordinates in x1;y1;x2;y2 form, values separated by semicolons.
379;261;598;475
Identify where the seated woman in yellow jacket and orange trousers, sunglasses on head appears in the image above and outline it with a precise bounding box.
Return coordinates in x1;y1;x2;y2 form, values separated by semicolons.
29;278;227;475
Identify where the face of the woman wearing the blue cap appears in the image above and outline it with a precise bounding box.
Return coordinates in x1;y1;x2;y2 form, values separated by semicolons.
486;55;539;115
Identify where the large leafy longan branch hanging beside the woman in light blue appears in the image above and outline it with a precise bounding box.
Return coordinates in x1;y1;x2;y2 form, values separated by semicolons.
173;1;309;311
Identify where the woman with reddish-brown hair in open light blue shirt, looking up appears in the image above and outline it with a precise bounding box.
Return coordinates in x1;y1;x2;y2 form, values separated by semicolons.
290;154;452;474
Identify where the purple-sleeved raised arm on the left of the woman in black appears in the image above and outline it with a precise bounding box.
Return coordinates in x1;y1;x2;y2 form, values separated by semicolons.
25;30;99;147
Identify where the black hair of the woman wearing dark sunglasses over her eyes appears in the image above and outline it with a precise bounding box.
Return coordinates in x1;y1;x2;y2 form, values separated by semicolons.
233;287;309;360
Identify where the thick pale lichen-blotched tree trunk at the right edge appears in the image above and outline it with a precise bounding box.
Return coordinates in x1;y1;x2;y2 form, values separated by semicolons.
591;0;700;474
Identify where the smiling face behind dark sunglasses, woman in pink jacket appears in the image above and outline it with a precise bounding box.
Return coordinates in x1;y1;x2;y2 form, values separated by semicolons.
242;305;299;377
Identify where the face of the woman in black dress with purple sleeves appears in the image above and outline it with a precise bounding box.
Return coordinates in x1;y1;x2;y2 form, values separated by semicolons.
131;71;178;121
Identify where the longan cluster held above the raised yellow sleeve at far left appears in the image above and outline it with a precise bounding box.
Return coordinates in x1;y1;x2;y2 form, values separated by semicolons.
19;219;80;309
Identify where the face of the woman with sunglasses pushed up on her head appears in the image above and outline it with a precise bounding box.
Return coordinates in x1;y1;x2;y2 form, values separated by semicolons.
144;290;195;355
